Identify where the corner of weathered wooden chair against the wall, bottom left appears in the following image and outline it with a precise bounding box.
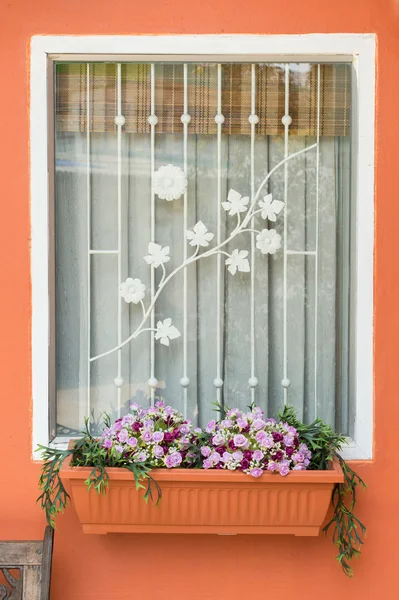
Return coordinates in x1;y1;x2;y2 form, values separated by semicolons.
0;527;54;600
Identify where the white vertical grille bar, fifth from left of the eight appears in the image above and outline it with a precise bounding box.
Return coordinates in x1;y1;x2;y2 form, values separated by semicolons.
213;64;224;403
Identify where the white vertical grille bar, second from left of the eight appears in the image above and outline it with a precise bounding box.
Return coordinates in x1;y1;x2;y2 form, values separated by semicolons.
116;63;123;417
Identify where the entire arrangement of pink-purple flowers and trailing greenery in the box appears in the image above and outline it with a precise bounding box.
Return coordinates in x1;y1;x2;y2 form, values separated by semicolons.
38;400;366;576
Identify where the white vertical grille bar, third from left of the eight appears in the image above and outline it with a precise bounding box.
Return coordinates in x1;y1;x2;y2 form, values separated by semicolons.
150;63;157;404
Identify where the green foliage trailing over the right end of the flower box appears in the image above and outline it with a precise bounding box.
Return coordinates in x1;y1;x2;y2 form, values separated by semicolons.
279;406;367;577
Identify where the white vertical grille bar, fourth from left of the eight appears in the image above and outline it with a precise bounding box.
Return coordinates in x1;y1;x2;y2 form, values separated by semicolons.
180;64;190;418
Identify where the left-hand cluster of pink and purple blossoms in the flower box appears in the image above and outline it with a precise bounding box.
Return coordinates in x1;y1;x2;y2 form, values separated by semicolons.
100;401;198;469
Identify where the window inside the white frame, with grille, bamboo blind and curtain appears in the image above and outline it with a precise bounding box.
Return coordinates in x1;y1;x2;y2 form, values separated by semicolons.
31;37;372;460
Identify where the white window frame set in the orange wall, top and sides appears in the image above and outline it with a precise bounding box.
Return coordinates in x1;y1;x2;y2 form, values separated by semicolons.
30;34;376;460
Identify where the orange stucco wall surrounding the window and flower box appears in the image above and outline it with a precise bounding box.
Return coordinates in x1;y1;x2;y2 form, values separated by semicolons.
0;0;399;600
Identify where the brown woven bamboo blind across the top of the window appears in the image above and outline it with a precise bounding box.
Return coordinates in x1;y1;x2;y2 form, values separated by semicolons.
56;63;351;136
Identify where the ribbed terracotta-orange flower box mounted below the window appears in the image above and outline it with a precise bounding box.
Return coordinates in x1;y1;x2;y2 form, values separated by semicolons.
60;459;344;536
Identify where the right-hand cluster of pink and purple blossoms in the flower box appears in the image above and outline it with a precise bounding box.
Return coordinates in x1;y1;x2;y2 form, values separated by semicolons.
201;407;312;477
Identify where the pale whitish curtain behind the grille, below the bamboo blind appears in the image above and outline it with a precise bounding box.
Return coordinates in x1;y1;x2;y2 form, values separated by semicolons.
55;132;350;432
